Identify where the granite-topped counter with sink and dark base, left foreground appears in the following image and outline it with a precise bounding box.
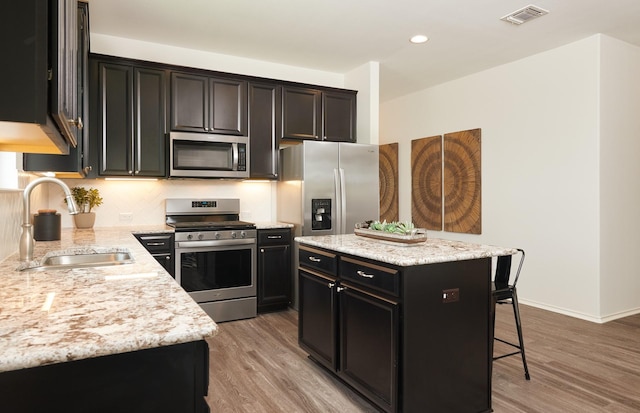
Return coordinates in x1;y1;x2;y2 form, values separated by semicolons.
0;226;217;412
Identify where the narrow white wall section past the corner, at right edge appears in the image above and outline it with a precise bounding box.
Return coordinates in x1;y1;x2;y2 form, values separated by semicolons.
600;36;640;317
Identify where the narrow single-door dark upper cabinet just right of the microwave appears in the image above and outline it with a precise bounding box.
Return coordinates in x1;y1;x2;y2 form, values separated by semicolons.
249;82;282;179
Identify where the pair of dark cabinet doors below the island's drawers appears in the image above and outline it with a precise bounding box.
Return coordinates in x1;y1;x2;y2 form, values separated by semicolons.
299;270;398;411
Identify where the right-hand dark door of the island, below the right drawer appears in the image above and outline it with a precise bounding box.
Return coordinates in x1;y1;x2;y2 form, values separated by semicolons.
337;286;399;412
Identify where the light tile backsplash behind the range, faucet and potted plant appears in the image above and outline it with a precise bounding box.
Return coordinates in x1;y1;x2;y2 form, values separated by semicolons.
0;174;275;261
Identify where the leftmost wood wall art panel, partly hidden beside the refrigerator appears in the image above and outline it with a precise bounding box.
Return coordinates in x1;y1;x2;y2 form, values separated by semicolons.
378;143;399;222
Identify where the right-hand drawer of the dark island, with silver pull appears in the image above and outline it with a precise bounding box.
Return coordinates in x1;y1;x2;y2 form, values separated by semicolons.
340;257;400;296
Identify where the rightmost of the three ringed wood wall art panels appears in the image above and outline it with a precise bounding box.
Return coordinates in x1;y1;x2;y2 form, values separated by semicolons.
443;129;482;234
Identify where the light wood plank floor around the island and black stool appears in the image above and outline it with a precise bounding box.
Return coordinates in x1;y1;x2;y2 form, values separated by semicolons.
207;305;640;413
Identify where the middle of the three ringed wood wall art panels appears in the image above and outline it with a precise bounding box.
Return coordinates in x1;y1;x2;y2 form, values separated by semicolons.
411;136;442;231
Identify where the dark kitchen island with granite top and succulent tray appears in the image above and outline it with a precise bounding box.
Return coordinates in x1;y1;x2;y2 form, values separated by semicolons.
295;234;517;413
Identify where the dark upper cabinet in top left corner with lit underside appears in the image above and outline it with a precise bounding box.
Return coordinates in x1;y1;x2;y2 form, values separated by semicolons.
0;0;82;154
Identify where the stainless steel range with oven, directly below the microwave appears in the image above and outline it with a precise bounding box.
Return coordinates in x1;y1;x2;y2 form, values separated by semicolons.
165;198;257;322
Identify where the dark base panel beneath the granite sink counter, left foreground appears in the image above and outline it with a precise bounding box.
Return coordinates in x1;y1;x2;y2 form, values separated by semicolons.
0;341;210;413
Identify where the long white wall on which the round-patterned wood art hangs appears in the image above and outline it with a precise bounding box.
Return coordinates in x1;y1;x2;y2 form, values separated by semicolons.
380;36;640;321
